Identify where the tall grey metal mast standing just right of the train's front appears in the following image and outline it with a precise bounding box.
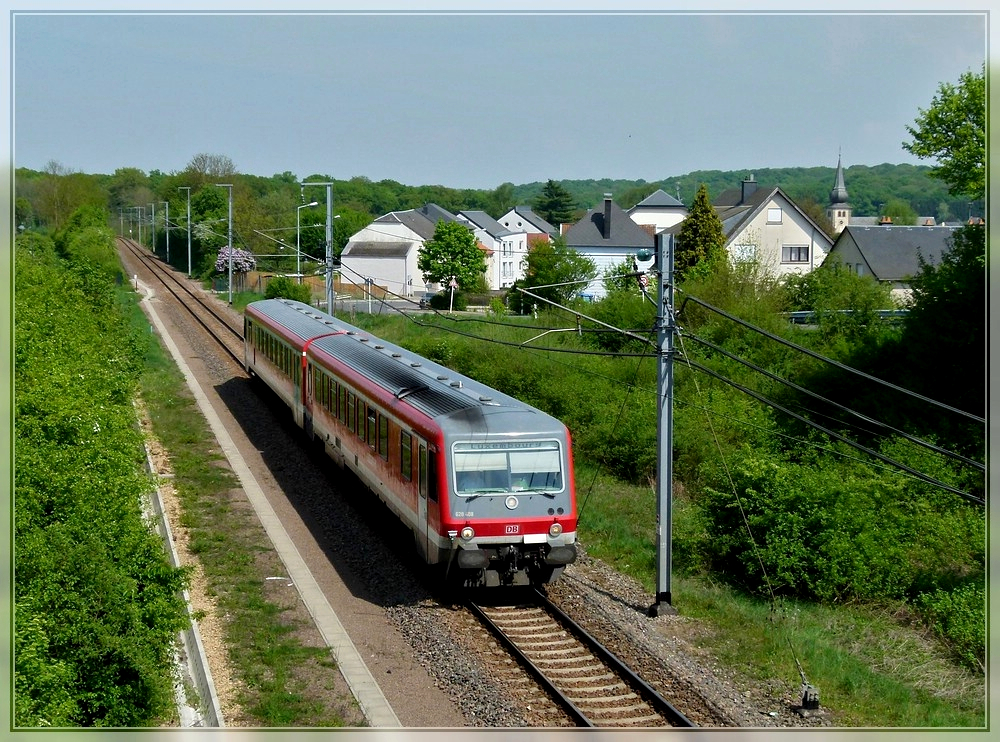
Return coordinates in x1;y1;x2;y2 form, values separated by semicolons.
649;234;676;616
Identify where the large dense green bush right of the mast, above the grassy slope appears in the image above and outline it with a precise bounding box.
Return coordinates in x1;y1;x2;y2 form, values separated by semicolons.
700;449;983;602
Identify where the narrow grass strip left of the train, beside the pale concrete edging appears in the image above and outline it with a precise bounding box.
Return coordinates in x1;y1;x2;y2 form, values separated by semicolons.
132;290;353;727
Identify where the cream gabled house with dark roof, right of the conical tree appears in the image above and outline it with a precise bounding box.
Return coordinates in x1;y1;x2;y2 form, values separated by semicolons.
680;175;833;277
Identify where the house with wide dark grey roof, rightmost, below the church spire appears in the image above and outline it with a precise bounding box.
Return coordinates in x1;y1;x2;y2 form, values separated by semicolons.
823;224;958;304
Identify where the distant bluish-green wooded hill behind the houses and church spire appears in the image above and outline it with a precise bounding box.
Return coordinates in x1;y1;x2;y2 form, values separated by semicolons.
514;163;982;227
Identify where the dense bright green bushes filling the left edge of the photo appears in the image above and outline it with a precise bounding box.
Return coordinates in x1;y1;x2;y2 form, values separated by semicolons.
14;227;186;727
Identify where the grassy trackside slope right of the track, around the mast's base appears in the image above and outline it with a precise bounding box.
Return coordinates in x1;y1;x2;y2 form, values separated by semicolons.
577;464;986;728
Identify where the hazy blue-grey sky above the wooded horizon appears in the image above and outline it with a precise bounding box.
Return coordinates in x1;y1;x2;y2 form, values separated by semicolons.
7;0;989;188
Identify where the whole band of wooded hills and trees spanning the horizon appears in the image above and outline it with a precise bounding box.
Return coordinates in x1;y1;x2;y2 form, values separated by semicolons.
14;164;983;235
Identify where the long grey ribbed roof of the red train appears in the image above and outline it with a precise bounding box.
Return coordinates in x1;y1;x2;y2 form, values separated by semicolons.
248;299;563;432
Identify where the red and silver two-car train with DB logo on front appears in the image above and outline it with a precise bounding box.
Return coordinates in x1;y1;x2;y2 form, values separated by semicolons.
244;299;576;586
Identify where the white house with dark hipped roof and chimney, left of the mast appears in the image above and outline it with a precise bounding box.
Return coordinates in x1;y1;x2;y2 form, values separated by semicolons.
563;193;655;299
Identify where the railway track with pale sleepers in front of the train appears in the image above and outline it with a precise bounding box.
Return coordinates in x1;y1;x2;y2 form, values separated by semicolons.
468;591;694;728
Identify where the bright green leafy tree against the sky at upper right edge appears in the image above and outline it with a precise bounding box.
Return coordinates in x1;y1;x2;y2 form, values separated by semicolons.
903;67;986;199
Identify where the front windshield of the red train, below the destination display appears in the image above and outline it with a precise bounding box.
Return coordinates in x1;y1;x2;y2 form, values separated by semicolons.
453;441;563;496
